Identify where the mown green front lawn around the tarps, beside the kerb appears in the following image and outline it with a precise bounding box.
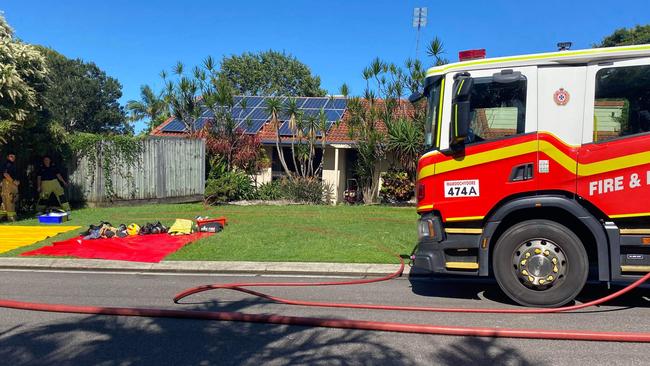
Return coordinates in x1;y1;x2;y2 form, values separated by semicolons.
0;204;417;263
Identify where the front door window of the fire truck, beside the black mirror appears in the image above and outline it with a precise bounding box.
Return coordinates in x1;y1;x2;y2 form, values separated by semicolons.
465;75;526;143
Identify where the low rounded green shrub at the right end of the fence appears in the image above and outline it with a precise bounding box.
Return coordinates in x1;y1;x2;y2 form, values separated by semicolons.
205;171;257;203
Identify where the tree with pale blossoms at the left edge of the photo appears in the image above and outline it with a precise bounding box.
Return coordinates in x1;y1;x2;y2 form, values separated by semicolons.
0;14;47;143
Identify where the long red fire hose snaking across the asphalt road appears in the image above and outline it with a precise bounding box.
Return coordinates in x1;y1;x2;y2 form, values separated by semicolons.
0;254;650;343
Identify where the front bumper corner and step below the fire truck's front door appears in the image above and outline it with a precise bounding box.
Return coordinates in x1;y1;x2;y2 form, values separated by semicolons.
413;214;480;276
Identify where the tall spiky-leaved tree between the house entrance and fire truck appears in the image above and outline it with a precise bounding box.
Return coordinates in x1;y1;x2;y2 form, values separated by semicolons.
341;58;426;203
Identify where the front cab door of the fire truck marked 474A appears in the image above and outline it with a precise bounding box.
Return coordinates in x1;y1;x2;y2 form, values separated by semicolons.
432;67;537;222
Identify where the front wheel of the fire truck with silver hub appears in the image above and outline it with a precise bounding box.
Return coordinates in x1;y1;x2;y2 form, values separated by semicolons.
492;220;589;307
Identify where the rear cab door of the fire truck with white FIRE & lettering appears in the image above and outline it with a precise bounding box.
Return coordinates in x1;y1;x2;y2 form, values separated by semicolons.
577;59;650;219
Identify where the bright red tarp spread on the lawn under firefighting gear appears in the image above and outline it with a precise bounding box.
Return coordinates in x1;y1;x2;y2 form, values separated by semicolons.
21;233;212;263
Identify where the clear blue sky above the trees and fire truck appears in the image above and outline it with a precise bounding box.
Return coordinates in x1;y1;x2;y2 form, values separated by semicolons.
0;0;650;132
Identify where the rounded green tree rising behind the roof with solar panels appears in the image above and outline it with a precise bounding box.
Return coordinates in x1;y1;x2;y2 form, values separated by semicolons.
220;50;326;97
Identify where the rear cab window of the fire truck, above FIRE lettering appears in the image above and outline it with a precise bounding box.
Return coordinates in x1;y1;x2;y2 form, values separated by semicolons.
594;65;650;142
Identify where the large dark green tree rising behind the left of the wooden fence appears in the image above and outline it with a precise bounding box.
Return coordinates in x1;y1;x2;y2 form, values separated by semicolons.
38;46;132;133
